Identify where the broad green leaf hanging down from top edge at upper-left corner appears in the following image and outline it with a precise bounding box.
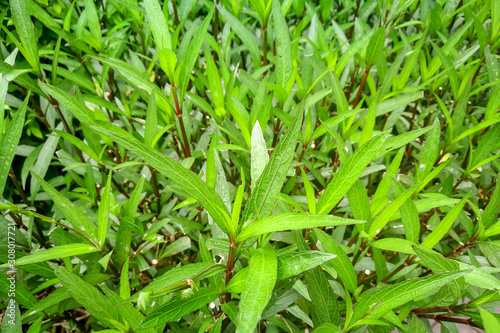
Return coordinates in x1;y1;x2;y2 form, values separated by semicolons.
10;0;40;73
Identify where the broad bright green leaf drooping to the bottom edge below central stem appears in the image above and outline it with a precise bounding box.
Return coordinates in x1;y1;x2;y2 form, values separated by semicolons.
237;249;278;333
